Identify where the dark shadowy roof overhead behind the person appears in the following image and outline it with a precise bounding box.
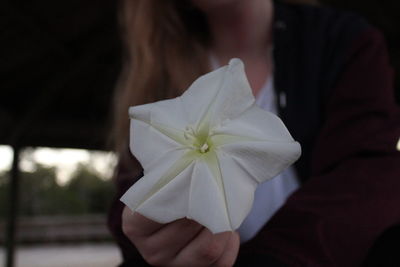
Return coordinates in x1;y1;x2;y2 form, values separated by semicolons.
0;0;400;149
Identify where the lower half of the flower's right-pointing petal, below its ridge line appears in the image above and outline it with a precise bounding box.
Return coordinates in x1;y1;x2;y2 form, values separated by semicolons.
219;141;301;183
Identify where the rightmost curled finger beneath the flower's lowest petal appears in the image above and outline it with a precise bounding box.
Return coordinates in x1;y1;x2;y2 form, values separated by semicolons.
172;228;237;267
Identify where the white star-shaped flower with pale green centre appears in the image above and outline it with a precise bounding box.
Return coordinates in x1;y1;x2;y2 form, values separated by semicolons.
121;59;301;233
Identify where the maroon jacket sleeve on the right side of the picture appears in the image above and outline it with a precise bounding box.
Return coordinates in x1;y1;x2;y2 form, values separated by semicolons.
241;29;400;267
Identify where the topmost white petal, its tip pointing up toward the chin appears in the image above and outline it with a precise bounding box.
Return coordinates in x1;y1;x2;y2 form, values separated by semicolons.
181;59;255;132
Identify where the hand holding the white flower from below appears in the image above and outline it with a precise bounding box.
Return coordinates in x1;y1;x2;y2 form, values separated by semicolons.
122;207;240;267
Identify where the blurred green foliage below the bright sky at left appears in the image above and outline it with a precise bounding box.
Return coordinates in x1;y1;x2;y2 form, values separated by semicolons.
0;164;114;217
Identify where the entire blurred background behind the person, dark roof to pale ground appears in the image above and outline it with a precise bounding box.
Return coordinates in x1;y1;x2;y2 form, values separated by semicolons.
0;0;400;267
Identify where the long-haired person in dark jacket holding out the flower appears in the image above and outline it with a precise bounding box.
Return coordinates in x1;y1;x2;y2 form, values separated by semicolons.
109;0;400;266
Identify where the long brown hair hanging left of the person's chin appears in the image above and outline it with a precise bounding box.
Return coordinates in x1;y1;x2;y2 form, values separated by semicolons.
113;0;316;151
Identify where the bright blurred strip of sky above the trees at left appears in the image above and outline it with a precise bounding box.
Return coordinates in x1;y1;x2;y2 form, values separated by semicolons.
0;146;117;184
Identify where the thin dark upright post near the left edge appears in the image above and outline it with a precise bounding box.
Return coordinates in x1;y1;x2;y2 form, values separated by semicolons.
5;146;20;267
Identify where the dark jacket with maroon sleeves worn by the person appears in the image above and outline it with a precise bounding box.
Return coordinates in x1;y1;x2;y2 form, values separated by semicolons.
110;2;400;267
